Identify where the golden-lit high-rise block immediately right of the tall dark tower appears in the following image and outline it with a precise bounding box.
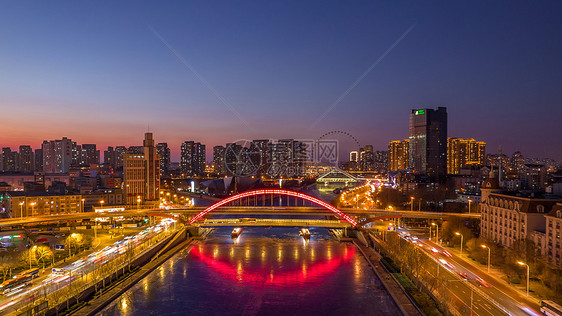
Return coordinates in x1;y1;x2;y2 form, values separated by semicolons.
447;137;486;174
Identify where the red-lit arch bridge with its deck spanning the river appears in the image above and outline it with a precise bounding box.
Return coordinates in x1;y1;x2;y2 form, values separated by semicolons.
179;189;399;228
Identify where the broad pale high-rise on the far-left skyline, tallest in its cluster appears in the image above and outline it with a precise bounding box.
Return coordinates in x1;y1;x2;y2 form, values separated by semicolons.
41;137;74;173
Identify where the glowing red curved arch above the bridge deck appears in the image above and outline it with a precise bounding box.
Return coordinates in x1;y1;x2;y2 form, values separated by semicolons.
189;189;357;227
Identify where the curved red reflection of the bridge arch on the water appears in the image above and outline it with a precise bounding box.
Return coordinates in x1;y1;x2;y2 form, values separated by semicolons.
190;247;355;287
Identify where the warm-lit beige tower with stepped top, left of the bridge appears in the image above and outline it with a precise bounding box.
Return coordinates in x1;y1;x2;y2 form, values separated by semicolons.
123;132;160;205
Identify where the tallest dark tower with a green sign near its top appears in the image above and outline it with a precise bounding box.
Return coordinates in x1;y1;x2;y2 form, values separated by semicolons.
409;107;447;182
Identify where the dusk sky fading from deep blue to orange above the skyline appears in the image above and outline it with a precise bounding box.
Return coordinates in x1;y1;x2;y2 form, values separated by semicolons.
0;1;562;160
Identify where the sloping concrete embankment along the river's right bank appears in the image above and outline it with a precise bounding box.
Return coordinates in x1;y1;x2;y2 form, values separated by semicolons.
352;238;424;316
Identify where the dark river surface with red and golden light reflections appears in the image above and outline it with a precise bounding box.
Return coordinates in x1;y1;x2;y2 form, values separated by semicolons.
101;228;398;315
